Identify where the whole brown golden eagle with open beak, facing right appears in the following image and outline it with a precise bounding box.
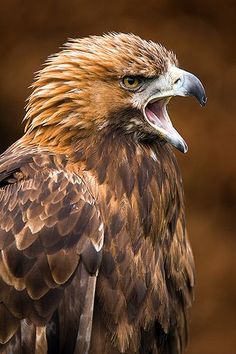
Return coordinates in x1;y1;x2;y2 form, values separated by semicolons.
0;33;206;354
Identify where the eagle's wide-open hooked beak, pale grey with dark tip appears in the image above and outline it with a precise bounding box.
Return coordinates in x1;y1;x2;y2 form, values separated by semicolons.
143;67;206;153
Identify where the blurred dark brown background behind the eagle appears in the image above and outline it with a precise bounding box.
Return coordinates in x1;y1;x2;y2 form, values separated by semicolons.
0;0;236;354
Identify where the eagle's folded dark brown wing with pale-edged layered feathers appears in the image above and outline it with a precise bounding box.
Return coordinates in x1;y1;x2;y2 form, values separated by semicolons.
0;153;103;353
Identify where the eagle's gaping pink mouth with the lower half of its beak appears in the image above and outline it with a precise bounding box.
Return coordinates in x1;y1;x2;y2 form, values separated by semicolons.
144;96;188;153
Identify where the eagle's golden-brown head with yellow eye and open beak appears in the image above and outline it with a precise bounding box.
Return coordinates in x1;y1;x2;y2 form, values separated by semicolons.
25;33;206;152
